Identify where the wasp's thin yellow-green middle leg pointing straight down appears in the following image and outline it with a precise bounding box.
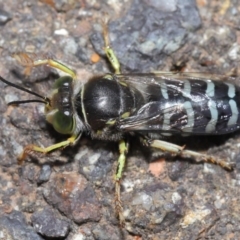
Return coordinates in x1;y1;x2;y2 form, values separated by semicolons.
115;140;129;227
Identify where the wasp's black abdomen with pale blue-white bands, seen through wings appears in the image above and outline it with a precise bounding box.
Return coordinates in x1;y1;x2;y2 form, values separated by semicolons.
145;79;240;135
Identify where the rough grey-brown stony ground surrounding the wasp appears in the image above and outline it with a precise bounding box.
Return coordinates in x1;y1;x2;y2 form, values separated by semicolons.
0;0;240;240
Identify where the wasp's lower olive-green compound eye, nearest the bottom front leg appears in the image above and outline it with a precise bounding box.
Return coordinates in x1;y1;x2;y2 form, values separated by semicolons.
52;111;74;134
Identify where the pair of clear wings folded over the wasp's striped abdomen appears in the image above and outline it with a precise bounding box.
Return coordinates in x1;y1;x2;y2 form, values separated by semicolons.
116;73;239;134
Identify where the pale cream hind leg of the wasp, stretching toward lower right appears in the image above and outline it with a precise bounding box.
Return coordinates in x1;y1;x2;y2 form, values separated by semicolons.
147;140;233;170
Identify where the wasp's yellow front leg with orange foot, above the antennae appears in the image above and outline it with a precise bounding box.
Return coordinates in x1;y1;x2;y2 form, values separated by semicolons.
13;53;76;79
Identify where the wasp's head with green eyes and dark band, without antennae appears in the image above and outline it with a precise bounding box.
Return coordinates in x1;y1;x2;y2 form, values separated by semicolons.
45;76;74;134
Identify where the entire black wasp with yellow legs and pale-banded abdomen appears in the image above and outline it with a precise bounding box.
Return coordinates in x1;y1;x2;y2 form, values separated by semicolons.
0;21;236;225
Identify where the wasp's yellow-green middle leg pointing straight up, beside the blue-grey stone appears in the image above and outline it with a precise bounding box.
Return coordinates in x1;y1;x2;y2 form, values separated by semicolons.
102;17;121;74
